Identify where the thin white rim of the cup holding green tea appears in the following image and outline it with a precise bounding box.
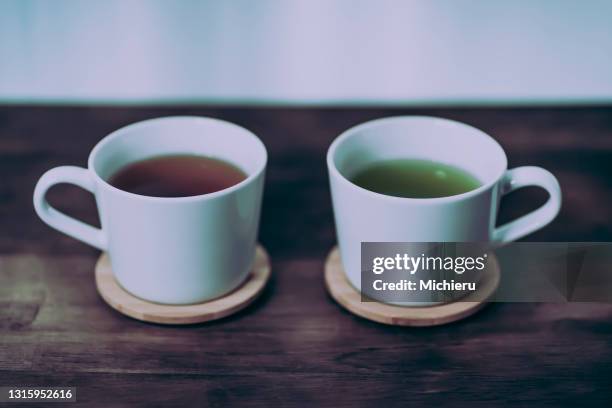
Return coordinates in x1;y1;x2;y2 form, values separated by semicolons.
327;115;508;203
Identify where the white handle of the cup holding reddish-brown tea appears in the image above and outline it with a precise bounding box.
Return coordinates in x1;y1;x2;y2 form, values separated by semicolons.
34;166;107;251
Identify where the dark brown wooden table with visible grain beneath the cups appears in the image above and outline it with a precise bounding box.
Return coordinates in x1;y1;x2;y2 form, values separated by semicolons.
0;106;612;407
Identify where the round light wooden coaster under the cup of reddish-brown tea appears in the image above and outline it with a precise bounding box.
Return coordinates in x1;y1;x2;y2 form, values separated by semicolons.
96;245;270;324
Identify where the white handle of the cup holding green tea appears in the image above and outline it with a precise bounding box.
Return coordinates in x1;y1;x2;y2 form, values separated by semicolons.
492;166;561;243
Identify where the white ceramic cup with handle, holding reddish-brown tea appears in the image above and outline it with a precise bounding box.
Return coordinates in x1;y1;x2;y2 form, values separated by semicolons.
34;116;267;304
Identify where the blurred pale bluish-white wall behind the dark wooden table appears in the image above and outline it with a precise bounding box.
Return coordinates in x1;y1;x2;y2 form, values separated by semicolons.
0;0;612;103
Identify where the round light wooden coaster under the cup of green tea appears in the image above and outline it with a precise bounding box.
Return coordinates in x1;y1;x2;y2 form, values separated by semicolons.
325;247;501;326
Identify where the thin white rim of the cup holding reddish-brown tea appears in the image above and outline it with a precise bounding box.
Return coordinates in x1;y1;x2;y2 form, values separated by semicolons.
87;115;268;203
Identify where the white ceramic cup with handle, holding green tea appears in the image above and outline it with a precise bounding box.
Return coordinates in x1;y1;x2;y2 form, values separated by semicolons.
327;116;561;294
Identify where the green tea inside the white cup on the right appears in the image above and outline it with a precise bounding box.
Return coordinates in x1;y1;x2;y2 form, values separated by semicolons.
351;159;480;198
